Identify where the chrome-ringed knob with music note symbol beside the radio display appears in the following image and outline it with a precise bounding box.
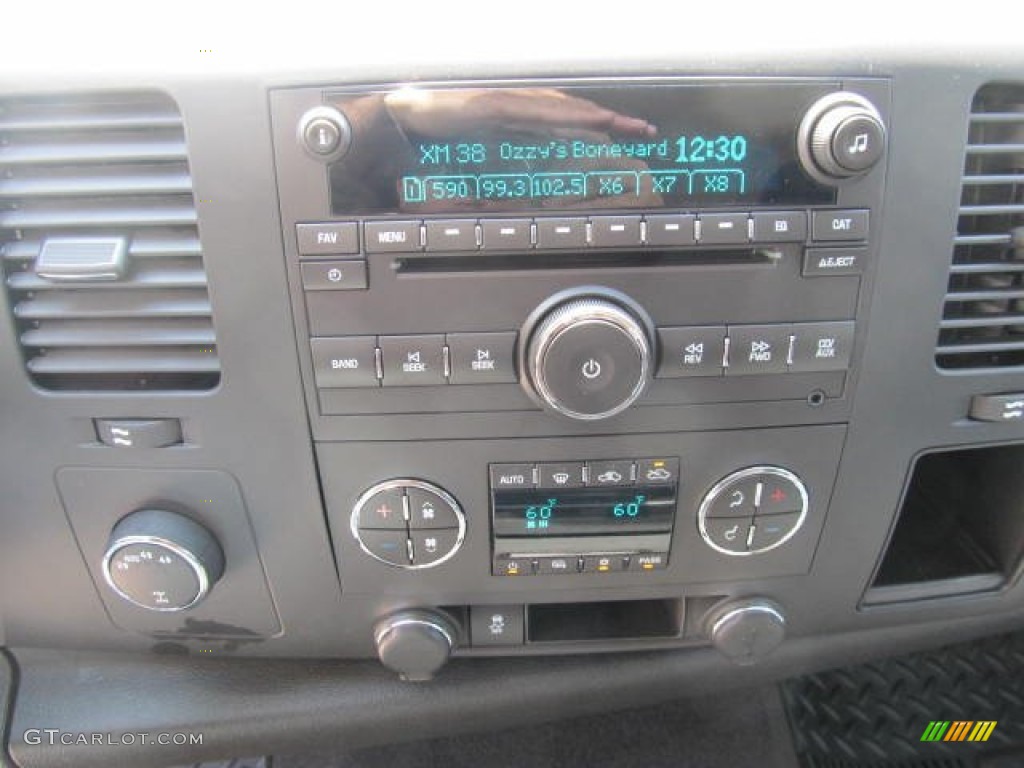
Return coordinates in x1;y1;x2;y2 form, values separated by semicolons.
799;91;886;185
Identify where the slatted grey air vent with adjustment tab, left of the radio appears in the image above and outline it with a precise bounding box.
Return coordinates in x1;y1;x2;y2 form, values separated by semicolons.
0;93;220;391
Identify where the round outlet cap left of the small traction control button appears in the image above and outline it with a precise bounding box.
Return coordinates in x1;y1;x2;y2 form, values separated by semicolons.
374;610;458;683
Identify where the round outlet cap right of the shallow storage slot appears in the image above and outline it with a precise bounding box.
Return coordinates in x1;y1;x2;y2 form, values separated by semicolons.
706;597;785;666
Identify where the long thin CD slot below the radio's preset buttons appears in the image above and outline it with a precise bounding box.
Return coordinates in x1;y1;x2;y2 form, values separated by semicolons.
395;247;783;274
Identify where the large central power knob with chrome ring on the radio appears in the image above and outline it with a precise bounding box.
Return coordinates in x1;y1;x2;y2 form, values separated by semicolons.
522;291;651;421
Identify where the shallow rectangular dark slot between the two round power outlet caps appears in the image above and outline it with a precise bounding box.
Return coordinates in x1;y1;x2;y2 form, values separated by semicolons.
526;599;683;643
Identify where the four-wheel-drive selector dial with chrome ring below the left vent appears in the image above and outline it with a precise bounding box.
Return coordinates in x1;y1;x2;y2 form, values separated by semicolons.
102;509;224;612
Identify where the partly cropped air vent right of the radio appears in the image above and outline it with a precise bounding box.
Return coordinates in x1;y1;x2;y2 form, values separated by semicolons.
936;84;1024;369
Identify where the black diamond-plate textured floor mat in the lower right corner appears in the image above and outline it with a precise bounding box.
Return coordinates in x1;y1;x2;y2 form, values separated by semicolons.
781;632;1024;768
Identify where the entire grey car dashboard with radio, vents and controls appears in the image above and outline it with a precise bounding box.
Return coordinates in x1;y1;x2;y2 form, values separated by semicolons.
0;16;1024;768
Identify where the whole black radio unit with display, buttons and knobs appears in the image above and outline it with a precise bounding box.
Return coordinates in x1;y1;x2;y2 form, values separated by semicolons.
271;78;889;439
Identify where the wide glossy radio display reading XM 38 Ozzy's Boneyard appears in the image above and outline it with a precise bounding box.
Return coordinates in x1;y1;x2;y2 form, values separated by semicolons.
329;82;836;215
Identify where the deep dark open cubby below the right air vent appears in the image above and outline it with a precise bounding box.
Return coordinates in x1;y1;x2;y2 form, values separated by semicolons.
864;445;1024;604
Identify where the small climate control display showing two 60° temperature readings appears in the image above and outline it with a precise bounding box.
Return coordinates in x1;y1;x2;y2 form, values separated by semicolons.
494;485;676;538
